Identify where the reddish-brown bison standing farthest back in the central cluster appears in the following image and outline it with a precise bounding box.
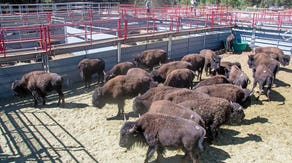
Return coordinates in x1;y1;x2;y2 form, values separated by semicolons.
200;49;221;76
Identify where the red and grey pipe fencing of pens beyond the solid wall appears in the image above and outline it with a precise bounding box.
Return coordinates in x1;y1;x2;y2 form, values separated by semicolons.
0;2;292;57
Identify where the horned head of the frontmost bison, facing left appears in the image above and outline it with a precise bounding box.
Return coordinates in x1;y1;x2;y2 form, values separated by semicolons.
119;122;138;148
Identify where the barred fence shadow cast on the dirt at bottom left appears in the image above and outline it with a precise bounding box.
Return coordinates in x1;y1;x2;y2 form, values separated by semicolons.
0;110;98;162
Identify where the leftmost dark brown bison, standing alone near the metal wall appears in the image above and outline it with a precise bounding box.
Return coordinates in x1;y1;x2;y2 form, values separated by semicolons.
11;71;65;107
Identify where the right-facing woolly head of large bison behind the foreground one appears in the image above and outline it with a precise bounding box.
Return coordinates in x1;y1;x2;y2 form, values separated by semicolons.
229;102;245;124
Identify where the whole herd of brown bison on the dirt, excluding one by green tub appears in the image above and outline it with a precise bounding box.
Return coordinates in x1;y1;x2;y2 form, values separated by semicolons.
11;47;290;162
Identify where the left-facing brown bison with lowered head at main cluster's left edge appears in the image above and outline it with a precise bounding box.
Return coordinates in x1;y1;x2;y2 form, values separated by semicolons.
92;75;154;115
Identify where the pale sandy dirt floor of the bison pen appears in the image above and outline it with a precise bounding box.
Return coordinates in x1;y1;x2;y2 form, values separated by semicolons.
0;53;292;163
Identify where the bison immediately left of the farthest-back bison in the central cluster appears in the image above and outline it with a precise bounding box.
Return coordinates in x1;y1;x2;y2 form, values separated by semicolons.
181;54;205;81
